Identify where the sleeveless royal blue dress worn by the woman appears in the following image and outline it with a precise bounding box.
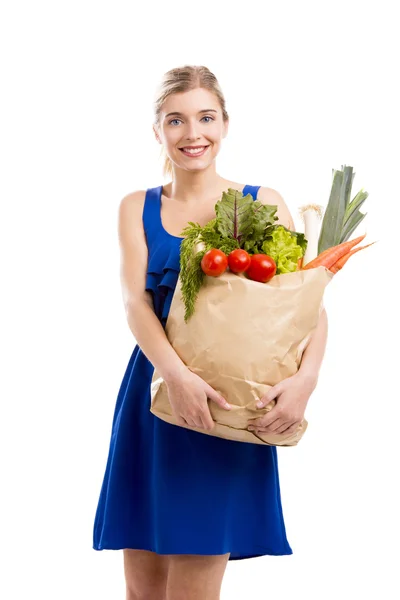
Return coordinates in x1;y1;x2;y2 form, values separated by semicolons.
93;185;293;560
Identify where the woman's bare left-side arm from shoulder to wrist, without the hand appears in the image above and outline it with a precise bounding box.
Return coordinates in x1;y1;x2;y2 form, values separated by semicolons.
118;191;186;381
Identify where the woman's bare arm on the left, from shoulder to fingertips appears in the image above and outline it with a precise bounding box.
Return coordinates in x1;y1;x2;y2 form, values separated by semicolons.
118;191;230;429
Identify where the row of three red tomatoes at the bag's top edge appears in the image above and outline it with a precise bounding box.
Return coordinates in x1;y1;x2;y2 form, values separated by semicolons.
201;248;276;283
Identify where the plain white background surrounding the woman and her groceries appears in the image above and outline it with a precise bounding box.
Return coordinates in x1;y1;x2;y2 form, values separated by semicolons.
0;0;400;600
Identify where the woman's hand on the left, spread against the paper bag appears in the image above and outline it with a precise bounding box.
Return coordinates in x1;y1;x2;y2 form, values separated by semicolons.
166;367;231;430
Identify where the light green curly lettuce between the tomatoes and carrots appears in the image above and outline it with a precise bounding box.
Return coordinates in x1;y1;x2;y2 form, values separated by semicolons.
262;225;307;275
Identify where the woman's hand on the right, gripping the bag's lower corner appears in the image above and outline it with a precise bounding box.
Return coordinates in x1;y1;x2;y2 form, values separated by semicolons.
248;371;316;434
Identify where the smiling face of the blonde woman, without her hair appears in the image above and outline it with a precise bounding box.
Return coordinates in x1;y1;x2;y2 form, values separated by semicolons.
155;88;228;170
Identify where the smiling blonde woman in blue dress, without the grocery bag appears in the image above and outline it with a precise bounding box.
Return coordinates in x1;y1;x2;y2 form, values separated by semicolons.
93;66;327;600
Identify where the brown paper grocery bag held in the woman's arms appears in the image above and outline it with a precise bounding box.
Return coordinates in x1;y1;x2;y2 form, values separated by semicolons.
150;266;334;446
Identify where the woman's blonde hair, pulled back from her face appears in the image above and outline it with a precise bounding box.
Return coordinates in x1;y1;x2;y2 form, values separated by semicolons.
154;65;228;177
